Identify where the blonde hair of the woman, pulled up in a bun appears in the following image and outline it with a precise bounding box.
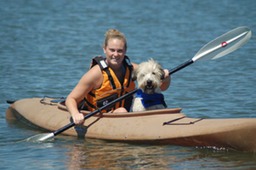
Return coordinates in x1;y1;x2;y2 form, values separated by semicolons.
103;29;127;50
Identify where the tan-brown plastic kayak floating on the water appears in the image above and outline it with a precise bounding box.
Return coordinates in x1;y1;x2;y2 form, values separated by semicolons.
6;97;256;152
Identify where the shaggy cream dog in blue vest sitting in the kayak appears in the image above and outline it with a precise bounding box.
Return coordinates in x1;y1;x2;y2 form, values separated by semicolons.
131;59;167;112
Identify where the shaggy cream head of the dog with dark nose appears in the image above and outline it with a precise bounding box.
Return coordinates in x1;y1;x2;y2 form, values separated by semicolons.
134;59;164;94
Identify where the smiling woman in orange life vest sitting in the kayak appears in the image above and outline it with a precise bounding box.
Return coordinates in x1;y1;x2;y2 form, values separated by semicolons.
66;29;170;124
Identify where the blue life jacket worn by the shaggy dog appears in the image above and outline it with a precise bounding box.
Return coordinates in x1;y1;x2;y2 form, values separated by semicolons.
136;89;167;108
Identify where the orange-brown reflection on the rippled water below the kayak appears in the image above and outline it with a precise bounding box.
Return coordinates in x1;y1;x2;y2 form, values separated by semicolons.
68;140;176;169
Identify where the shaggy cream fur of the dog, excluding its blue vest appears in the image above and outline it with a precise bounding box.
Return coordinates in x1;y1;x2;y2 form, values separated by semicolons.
131;59;165;111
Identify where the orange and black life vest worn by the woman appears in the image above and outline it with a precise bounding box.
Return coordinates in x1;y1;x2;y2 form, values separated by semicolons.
85;56;135;112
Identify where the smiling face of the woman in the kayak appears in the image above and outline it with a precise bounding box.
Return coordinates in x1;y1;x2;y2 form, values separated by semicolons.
103;38;126;68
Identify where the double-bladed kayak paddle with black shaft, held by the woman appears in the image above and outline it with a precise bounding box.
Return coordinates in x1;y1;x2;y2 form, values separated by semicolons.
28;27;252;141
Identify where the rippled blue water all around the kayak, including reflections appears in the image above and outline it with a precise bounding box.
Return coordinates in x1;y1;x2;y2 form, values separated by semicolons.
0;0;256;169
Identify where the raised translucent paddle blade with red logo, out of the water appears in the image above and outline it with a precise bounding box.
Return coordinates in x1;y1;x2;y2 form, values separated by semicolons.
192;26;252;62
